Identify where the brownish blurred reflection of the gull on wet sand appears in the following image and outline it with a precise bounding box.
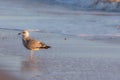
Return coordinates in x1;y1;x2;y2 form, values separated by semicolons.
21;56;40;78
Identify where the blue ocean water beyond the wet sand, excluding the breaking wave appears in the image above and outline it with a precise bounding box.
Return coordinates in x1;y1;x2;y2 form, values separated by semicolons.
0;0;120;36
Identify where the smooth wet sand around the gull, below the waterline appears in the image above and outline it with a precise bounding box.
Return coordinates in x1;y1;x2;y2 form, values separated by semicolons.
0;30;120;80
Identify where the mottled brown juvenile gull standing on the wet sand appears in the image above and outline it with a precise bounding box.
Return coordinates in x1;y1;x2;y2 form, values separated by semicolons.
18;30;50;58
